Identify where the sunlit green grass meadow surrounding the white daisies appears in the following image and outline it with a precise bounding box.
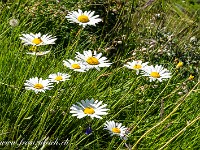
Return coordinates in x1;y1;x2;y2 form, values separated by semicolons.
0;0;200;150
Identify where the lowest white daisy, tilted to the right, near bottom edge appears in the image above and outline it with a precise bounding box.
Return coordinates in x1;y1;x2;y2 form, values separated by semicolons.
104;121;127;140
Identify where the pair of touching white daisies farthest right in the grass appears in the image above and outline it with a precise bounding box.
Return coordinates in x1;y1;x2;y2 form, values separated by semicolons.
124;60;171;82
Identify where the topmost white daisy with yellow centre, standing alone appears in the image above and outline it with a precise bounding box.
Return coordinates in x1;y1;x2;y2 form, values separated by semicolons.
65;9;102;27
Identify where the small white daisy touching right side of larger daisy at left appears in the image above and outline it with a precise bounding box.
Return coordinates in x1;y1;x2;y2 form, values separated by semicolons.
49;72;70;83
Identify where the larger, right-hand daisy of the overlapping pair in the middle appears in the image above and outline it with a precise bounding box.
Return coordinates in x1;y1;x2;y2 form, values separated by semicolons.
76;50;112;70
